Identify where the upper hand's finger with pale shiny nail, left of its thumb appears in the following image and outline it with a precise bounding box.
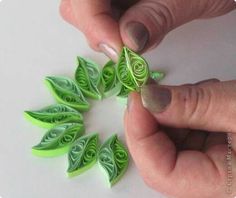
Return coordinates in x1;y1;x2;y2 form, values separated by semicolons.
64;0;123;61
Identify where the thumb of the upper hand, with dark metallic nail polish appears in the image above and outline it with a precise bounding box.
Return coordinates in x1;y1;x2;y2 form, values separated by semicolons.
120;0;235;52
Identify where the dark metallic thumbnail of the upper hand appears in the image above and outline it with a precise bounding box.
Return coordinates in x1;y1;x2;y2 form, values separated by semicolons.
125;22;149;52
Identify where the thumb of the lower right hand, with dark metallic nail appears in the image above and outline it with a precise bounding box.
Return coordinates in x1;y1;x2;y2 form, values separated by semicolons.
141;80;236;132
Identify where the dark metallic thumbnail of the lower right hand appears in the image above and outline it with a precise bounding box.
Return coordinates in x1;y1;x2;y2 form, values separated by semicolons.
141;84;171;113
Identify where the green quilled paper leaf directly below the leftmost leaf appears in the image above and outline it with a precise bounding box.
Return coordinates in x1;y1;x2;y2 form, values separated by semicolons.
32;123;84;157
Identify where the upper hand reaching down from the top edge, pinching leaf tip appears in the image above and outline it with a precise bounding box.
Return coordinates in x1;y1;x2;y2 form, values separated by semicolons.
60;0;236;60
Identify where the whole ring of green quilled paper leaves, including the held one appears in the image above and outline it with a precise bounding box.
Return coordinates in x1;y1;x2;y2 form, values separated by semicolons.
24;47;164;186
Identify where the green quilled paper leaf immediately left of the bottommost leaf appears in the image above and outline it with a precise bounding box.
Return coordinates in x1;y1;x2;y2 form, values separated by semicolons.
67;134;98;177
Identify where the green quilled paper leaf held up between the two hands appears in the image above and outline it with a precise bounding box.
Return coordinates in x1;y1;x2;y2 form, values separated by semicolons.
117;47;149;91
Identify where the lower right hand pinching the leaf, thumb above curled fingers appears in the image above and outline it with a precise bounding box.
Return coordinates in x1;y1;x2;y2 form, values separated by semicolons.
124;80;236;198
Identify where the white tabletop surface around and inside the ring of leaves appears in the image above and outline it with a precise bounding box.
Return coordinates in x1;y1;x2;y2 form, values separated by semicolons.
0;0;236;198
